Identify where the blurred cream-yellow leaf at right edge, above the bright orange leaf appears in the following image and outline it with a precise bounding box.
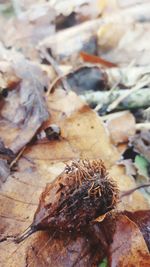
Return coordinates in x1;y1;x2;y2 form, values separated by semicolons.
98;21;150;66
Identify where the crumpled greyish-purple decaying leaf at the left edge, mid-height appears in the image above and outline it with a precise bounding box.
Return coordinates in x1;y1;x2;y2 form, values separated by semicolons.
0;57;49;153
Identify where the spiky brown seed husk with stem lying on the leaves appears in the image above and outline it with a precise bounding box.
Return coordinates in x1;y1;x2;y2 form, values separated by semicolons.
33;160;119;232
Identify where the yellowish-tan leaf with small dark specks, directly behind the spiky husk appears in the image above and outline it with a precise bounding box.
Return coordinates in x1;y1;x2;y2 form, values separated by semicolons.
23;90;119;170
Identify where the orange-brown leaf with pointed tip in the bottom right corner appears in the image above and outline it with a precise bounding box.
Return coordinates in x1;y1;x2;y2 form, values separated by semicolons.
109;215;150;267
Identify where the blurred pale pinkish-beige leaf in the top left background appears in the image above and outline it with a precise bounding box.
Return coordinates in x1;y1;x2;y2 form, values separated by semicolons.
0;2;55;59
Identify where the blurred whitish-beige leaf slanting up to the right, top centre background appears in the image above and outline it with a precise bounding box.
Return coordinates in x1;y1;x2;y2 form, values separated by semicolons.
38;19;101;63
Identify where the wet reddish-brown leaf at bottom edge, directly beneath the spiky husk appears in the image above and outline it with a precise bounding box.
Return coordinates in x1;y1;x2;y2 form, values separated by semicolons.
26;233;103;267
